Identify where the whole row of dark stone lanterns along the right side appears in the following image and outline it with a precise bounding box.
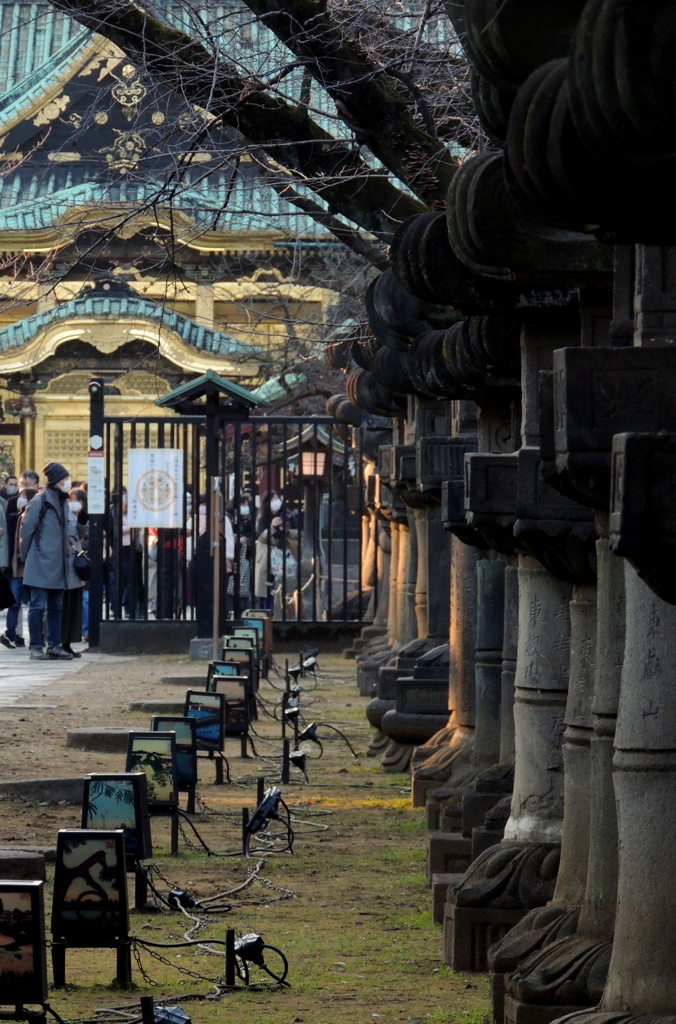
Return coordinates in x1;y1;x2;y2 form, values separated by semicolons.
331;0;676;1024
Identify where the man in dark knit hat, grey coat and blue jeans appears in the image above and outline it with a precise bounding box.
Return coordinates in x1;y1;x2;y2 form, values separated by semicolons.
18;462;73;660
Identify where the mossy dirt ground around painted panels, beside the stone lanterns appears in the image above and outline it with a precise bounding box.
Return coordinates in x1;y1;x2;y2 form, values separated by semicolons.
0;655;490;1024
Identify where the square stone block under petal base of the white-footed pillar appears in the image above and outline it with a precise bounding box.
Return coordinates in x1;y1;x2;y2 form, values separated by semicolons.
443;900;526;971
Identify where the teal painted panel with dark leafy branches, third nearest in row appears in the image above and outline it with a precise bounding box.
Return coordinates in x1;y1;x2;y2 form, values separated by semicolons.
82;772;153;861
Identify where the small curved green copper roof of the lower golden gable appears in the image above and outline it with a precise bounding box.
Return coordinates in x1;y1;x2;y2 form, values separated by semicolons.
0;279;263;360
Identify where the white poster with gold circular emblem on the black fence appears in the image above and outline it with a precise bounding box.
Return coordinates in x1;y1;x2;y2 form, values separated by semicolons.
127;449;183;528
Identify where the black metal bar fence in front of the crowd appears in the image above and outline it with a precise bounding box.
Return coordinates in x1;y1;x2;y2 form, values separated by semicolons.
90;416;377;636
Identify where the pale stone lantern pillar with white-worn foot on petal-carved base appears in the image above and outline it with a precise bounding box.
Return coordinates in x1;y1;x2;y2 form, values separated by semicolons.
445;556;571;970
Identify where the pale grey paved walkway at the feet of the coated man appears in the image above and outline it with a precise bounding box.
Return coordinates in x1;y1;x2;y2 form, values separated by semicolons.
0;644;133;708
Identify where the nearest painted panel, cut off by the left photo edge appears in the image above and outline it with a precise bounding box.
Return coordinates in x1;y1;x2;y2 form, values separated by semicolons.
0;882;47;1004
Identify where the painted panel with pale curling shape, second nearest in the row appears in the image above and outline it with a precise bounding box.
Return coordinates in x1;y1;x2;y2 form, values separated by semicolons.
51;829;129;946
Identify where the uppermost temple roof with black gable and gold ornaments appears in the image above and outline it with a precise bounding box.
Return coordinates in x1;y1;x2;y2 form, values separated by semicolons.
0;7;329;240
